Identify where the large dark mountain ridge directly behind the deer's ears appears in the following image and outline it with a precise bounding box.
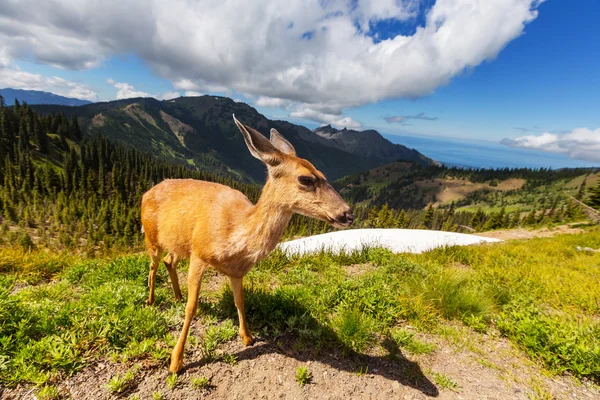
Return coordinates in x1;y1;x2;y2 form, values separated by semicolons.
34;96;433;182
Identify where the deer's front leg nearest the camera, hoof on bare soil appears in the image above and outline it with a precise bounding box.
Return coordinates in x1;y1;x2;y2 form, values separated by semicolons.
169;256;206;372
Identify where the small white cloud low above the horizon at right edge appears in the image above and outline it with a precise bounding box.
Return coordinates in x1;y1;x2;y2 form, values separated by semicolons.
500;128;600;162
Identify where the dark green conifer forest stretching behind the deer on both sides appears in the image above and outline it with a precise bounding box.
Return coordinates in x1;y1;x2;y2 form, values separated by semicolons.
0;98;600;253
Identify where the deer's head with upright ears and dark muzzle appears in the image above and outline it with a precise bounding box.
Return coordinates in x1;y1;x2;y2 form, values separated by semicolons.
233;115;354;228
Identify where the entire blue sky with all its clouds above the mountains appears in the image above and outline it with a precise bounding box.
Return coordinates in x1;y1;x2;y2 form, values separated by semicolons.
0;0;600;163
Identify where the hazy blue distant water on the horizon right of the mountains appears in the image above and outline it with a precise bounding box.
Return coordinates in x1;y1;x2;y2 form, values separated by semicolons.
384;134;600;168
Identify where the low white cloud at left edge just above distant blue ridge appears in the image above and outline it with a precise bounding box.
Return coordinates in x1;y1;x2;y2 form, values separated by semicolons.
0;65;98;101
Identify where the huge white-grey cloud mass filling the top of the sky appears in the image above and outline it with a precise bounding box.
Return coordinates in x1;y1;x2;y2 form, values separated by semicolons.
0;0;540;110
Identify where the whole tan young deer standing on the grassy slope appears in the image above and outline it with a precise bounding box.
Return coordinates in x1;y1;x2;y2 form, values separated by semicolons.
142;116;354;372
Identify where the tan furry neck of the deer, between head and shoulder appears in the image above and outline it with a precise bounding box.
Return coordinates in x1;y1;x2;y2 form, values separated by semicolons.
245;179;292;257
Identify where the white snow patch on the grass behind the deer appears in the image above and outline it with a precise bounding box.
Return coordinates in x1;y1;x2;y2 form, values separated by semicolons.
279;229;501;254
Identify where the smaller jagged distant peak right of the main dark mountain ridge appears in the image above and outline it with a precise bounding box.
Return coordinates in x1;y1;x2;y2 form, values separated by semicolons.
314;125;432;165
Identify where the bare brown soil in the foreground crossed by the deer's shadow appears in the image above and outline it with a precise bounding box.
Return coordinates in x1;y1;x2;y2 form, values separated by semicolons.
0;326;600;400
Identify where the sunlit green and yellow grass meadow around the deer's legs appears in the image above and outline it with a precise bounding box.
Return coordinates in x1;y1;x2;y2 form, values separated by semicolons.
0;229;600;390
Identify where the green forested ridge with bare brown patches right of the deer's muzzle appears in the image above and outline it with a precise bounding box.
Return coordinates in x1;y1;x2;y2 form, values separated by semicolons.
334;162;600;212
